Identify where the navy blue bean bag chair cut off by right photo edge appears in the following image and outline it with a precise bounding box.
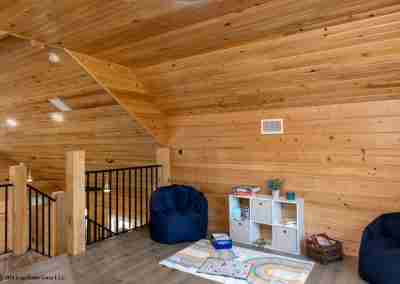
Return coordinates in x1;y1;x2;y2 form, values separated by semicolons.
359;213;400;284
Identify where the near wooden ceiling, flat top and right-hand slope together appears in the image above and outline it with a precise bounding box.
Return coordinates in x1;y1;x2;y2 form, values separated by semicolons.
0;0;400;115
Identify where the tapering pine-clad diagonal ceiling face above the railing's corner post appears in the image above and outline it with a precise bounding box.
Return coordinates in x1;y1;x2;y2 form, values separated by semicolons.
66;50;168;146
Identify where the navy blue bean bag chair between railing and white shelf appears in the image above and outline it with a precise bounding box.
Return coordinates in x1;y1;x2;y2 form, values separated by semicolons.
150;185;208;244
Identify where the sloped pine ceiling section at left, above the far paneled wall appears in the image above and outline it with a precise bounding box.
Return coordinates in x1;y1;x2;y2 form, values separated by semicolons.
0;36;116;115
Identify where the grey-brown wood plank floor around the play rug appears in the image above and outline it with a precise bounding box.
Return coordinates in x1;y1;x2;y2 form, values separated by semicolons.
2;228;365;284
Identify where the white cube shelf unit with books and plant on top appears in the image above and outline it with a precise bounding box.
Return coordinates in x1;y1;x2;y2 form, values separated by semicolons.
229;194;304;254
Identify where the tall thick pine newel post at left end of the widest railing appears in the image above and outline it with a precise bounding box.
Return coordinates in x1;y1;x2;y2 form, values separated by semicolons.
64;151;86;255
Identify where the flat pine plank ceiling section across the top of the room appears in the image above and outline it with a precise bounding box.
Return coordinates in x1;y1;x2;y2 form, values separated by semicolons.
0;0;400;67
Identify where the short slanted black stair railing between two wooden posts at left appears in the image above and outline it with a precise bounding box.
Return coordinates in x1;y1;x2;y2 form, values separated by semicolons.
27;184;56;257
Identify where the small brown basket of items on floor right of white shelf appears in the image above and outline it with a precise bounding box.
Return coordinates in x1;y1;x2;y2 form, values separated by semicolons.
306;234;343;264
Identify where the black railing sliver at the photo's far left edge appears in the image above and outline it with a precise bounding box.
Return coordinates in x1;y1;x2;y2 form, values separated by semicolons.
0;184;13;254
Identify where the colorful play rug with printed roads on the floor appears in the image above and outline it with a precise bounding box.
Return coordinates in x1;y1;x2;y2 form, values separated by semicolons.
160;240;314;284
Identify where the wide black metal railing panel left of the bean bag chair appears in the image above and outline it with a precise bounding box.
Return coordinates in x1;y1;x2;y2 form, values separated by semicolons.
86;165;162;244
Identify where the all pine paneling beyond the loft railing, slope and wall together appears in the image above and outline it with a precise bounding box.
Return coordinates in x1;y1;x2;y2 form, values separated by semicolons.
0;36;156;190
